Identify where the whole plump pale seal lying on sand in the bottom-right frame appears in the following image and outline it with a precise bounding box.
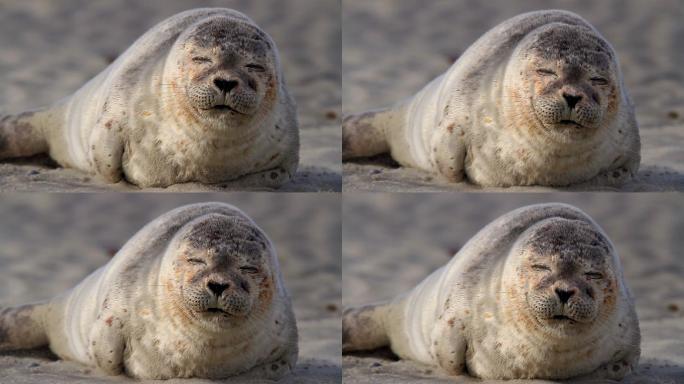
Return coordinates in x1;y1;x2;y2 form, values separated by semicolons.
342;204;640;379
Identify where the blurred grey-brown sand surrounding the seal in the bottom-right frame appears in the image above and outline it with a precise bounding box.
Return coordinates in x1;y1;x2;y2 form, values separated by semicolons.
342;193;684;384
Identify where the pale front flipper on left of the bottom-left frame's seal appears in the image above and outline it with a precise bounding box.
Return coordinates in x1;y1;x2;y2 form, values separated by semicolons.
88;311;126;376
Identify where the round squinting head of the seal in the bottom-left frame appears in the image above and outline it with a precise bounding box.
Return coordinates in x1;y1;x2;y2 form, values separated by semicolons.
160;214;275;330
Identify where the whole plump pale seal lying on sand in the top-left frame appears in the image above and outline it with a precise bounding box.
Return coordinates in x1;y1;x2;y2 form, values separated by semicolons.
0;8;299;188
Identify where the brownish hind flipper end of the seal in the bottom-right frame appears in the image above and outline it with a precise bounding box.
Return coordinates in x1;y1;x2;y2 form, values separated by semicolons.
342;303;391;352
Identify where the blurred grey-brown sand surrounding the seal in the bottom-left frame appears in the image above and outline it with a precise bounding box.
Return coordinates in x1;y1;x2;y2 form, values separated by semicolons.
0;193;341;384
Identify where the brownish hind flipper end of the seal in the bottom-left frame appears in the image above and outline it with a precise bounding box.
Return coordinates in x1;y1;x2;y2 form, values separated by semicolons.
0;303;48;351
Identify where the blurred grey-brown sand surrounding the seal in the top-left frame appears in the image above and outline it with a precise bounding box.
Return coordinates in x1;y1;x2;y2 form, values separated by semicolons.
0;0;342;192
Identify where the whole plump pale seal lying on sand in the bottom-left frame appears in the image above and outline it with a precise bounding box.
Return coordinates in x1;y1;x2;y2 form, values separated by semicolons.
0;203;298;379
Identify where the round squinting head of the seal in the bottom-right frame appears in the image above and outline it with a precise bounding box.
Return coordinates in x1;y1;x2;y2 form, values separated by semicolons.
503;218;618;342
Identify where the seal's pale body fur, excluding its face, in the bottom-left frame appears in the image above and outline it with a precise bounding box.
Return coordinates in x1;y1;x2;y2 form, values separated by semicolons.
0;203;298;379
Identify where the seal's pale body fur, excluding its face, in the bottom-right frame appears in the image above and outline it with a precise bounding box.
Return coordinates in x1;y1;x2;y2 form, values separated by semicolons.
343;203;640;380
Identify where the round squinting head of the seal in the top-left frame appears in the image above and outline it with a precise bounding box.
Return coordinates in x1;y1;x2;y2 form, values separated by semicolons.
168;16;278;126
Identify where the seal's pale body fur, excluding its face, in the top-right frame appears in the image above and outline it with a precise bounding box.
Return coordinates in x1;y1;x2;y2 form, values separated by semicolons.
343;10;640;187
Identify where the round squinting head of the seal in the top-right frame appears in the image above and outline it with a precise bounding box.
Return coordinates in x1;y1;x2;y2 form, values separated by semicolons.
505;23;620;143
